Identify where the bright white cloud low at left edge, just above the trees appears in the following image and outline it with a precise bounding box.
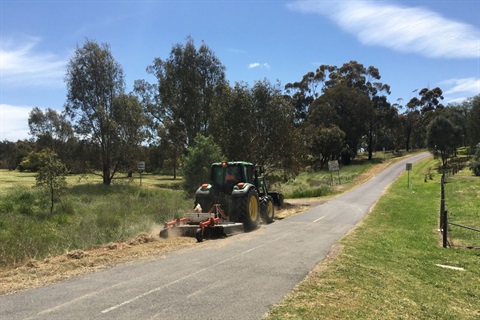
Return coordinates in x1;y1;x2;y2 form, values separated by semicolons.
0;104;33;141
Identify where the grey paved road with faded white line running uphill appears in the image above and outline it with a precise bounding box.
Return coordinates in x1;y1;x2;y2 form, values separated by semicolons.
0;153;428;320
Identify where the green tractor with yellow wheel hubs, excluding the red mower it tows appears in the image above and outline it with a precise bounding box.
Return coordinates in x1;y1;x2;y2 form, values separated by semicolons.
195;161;283;232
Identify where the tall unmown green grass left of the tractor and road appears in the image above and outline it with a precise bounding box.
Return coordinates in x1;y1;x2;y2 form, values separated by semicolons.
0;171;193;266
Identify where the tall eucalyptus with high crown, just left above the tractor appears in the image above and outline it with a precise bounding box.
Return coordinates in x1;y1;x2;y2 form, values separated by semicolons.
147;37;226;146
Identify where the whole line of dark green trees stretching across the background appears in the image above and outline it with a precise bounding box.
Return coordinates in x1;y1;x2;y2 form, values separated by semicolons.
0;37;480;185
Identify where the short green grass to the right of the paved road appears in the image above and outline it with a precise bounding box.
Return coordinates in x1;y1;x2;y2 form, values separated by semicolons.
267;156;480;319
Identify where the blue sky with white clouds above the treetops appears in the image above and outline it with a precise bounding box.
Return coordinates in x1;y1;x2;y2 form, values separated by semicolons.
0;0;480;141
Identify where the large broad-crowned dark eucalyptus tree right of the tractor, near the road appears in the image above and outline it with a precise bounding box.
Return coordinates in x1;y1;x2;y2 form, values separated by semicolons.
292;61;394;162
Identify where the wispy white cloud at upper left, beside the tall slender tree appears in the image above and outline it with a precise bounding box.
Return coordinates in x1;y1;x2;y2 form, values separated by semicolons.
0;38;67;87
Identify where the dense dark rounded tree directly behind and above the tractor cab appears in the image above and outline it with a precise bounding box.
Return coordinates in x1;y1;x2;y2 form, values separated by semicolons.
212;80;301;178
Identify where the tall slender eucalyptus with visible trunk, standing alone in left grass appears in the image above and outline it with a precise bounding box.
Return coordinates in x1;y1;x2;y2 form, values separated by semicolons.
65;39;129;185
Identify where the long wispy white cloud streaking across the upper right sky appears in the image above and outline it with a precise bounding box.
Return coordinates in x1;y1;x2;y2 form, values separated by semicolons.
287;0;480;58
